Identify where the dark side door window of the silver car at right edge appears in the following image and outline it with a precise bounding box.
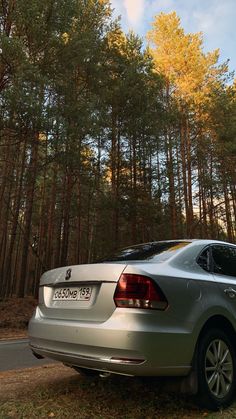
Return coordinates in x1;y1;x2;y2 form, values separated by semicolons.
212;245;236;277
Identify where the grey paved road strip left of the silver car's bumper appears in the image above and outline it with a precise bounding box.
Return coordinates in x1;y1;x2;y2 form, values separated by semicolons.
0;339;53;371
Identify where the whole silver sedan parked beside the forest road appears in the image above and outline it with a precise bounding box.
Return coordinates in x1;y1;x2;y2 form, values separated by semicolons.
29;240;236;409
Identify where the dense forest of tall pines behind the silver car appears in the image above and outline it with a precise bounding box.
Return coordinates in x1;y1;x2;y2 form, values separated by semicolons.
0;0;236;299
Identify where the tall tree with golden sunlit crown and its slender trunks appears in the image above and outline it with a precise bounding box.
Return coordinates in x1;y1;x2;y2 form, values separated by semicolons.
148;12;232;237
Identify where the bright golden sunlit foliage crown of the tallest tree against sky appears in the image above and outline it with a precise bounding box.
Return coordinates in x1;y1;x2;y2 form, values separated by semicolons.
147;12;219;102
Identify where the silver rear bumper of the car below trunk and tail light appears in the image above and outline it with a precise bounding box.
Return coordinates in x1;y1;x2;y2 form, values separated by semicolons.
29;308;193;376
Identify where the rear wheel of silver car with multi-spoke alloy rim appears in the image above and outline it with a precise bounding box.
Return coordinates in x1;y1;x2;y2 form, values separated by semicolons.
197;329;236;410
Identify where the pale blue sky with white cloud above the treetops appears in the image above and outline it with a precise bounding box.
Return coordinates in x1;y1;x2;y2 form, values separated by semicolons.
110;0;236;71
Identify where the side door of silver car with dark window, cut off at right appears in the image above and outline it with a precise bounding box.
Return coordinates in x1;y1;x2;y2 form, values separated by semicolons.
211;244;236;321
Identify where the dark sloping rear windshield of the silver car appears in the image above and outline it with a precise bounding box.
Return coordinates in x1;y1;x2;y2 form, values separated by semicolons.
99;241;190;263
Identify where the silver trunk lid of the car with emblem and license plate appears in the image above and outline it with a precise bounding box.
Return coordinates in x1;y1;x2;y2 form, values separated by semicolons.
39;263;126;322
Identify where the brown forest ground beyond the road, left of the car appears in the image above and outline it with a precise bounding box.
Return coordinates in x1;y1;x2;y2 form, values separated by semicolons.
0;297;37;339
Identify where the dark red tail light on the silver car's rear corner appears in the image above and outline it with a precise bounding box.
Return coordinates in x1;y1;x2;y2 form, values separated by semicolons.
114;274;168;310
